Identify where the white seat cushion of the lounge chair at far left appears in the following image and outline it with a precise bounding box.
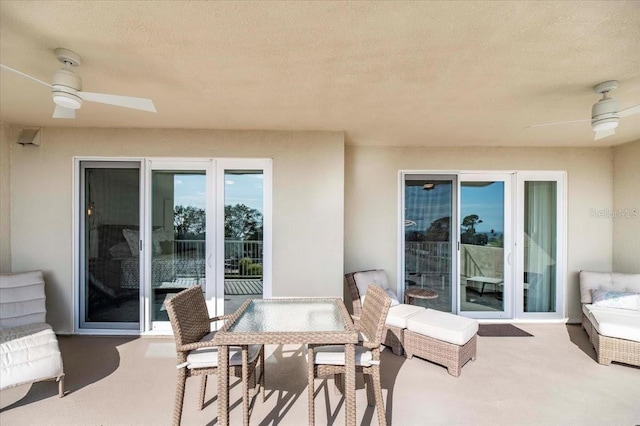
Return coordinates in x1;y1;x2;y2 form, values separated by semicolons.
0;323;64;389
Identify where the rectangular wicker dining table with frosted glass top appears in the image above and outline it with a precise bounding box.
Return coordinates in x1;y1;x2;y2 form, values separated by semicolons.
214;298;358;426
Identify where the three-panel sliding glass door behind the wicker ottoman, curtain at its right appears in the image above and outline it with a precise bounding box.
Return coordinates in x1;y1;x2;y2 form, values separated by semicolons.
398;172;566;319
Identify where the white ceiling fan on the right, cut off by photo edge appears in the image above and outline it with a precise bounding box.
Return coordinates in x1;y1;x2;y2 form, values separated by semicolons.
529;80;640;141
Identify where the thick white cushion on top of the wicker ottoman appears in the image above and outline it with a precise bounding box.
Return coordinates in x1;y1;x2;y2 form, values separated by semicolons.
407;309;478;346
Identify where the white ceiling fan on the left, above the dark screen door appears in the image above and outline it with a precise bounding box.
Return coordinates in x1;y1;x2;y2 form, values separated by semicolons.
0;48;157;118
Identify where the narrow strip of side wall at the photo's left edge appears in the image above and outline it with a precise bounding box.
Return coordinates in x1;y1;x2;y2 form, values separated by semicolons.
0;123;11;272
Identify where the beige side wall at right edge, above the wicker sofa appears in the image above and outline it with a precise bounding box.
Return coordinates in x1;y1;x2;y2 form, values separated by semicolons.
605;141;640;274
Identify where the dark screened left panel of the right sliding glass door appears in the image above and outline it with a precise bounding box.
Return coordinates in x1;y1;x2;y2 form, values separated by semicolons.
404;175;457;312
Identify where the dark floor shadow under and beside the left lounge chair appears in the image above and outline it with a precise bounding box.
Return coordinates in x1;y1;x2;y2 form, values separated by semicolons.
0;336;137;413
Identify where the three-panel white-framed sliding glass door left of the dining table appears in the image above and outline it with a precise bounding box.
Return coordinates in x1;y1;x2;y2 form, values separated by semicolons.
76;158;271;334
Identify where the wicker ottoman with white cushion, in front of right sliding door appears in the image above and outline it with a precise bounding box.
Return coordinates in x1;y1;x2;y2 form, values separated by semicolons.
404;309;478;377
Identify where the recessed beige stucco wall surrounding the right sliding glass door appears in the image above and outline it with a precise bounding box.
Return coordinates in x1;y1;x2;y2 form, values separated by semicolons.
345;146;613;321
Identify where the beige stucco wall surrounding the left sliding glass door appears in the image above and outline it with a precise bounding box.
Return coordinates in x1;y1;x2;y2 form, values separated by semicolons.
11;128;344;333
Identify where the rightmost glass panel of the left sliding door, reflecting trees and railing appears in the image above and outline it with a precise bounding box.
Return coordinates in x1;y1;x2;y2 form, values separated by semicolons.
224;169;264;313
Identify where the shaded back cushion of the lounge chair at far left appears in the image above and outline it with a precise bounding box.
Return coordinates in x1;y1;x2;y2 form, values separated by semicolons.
0;271;47;330
